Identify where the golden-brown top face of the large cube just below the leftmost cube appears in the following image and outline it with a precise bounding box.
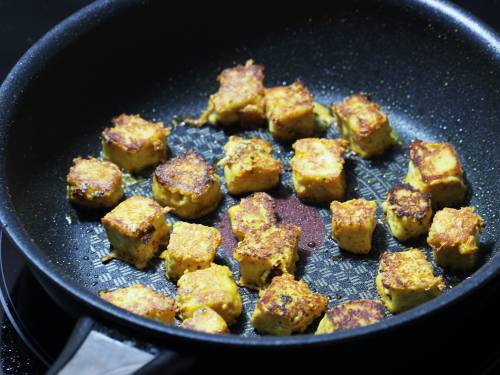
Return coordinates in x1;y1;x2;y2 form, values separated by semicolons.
101;195;170;238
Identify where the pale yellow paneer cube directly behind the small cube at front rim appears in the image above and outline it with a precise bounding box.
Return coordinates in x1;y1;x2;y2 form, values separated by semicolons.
176;264;242;325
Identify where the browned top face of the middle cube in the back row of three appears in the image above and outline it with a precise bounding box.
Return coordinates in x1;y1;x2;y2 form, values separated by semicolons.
266;81;313;125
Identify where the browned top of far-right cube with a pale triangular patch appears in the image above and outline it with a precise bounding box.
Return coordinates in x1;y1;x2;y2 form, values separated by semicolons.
409;140;463;183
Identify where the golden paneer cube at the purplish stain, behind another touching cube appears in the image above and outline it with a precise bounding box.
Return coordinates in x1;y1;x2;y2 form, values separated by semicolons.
228;193;277;241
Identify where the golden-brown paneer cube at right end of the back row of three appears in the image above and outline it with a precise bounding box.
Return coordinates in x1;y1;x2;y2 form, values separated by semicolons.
332;94;394;158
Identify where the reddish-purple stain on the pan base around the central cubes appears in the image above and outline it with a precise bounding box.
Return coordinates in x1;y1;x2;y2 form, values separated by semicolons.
217;195;325;255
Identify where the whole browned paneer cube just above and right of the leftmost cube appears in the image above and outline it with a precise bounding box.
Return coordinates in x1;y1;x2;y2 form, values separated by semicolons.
102;114;170;172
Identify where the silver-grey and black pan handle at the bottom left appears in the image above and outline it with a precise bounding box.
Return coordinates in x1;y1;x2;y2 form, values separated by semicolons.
47;316;193;375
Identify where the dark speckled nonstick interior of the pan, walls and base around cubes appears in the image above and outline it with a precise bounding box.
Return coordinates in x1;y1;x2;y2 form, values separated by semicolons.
0;1;500;336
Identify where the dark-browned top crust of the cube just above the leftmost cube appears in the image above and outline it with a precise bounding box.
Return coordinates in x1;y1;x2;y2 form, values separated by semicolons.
102;114;170;155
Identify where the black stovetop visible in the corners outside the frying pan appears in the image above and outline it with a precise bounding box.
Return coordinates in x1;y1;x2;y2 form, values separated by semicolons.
0;0;500;374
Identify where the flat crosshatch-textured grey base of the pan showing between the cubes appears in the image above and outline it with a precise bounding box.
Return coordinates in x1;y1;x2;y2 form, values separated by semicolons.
77;121;466;335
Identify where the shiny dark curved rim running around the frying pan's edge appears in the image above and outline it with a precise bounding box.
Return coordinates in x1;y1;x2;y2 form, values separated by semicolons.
0;0;500;348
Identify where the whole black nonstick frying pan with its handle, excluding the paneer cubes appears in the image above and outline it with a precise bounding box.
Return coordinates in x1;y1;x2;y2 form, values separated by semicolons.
0;0;500;372
